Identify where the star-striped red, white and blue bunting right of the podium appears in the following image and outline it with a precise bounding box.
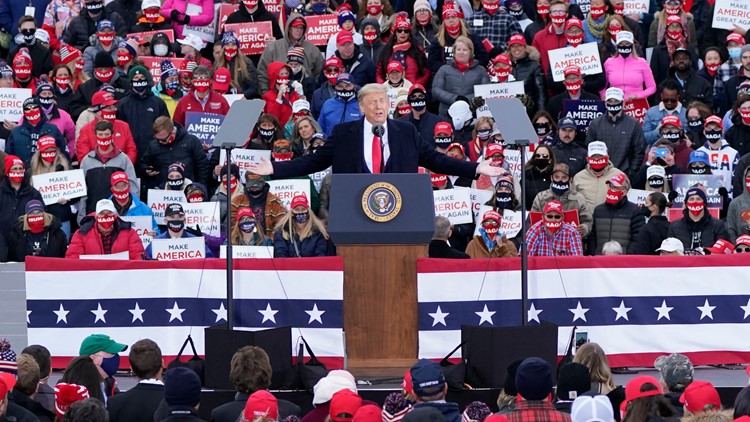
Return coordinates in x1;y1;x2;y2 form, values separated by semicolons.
417;254;750;366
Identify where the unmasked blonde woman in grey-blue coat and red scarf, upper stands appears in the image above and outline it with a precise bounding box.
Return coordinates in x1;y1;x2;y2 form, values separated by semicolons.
432;36;490;116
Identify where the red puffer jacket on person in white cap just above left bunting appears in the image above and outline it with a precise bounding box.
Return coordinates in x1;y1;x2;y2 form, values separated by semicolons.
65;213;143;260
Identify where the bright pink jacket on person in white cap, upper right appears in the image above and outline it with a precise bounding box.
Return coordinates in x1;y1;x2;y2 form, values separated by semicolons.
602;55;656;101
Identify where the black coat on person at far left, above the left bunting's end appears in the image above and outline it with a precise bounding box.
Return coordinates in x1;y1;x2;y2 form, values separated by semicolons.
7;213;68;262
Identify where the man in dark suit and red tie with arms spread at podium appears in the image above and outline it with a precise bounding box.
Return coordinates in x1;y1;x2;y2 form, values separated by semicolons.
249;84;502;179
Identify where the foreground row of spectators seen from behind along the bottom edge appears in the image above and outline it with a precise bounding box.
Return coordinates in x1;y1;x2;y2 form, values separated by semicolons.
0;334;750;422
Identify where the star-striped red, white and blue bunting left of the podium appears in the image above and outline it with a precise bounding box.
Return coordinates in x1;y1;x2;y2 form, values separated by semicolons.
26;257;344;368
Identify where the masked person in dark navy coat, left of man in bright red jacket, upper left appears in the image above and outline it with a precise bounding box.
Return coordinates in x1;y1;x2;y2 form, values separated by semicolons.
115;66;169;163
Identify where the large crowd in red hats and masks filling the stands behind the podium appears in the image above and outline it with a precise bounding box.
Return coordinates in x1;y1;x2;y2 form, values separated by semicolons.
0;0;750;261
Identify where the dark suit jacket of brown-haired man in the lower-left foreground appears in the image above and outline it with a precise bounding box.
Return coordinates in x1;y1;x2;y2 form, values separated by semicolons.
107;383;164;422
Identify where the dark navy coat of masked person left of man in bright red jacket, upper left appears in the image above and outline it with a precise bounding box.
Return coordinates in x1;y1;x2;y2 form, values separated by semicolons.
117;89;169;163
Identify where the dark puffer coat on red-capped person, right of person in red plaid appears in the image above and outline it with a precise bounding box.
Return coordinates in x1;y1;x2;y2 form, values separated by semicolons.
589;198;646;255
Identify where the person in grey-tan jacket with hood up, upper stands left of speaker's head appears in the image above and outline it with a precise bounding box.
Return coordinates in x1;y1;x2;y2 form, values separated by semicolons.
258;14;324;95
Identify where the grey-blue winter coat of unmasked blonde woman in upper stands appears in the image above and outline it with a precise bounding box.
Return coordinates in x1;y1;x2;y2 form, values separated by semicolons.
432;60;490;117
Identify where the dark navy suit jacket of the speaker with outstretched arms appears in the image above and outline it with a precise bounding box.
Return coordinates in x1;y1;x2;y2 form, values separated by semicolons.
273;118;477;179
